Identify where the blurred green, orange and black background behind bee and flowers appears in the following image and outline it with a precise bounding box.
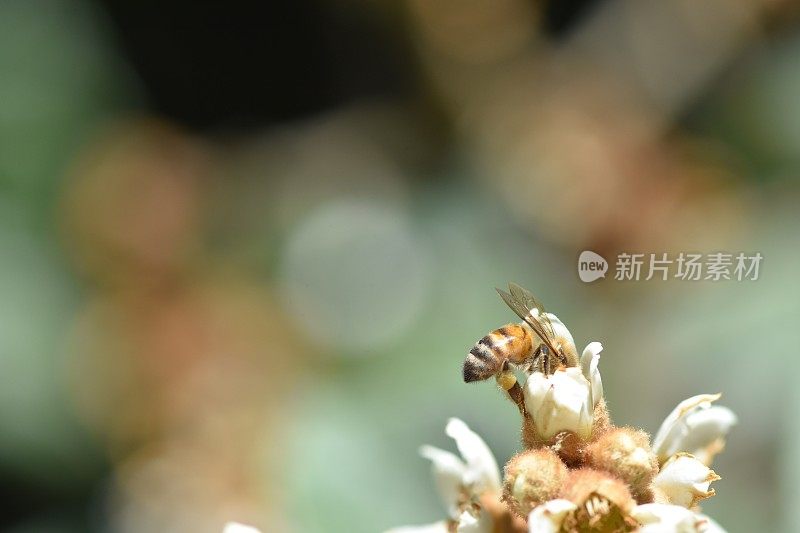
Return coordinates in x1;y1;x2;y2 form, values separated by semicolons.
0;0;800;533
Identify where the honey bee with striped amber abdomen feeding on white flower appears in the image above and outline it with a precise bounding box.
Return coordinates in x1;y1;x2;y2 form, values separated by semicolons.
464;283;578;384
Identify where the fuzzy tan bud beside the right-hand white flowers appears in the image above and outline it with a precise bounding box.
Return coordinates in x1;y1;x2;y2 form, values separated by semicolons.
585;427;658;501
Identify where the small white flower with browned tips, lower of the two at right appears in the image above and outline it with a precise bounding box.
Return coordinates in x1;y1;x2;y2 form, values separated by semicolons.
653;453;719;508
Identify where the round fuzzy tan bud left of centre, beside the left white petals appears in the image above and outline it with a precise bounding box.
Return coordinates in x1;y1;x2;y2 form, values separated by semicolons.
503;448;569;516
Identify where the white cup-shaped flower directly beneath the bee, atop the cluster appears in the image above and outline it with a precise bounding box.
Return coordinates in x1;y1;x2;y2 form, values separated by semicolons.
524;367;594;439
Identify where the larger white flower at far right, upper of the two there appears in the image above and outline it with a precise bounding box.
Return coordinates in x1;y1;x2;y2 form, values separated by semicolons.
653;394;736;465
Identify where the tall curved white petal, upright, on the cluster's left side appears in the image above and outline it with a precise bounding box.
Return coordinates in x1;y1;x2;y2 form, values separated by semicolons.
445;418;501;493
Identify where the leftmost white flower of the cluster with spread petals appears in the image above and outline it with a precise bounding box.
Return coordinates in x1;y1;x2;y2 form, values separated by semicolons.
387;418;501;533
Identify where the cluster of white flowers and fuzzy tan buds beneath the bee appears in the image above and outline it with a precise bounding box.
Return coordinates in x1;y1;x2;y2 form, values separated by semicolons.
391;315;736;533
